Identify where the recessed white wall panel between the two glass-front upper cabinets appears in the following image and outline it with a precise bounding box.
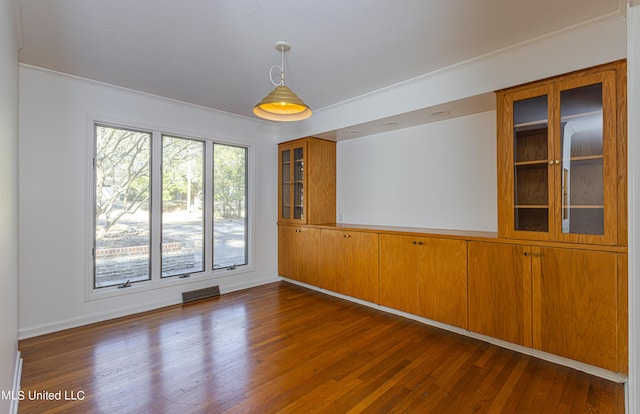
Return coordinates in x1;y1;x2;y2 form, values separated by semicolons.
337;111;498;231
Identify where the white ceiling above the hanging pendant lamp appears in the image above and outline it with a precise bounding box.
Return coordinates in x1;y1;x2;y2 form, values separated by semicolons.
19;0;625;123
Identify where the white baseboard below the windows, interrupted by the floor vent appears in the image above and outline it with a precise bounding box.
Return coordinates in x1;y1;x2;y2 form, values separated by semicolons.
18;277;281;340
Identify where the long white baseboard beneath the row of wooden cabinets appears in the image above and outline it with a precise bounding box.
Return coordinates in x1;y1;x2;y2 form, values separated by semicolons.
283;278;628;384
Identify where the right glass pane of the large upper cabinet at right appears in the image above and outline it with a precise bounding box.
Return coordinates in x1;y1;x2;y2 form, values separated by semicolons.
560;83;604;235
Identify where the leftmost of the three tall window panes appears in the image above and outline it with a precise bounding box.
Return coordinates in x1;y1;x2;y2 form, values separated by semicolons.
94;125;151;287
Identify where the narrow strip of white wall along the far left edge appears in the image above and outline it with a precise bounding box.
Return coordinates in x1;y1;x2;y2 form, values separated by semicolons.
0;0;18;413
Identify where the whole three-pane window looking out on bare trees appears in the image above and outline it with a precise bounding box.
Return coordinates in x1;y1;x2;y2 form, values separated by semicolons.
92;123;248;289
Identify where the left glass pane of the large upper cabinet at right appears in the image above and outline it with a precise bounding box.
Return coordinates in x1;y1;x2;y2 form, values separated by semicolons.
513;95;549;232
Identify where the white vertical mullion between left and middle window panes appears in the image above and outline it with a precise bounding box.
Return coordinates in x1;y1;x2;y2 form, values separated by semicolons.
150;131;162;282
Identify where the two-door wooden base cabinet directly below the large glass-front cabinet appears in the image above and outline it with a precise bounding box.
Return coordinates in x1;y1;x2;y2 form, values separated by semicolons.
469;242;627;372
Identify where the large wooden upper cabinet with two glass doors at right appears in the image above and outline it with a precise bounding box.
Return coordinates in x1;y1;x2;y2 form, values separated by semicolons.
497;62;626;245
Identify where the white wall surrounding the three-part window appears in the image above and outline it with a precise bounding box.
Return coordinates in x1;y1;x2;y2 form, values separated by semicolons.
19;66;277;337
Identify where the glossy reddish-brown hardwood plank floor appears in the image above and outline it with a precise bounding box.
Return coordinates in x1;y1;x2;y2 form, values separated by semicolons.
20;282;624;414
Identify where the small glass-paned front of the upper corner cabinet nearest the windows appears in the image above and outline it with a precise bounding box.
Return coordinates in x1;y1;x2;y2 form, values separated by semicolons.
278;142;307;224
